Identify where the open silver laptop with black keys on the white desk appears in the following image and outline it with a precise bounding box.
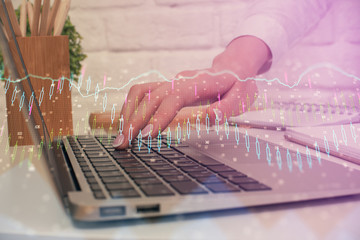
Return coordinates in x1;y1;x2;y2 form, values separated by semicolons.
0;2;360;222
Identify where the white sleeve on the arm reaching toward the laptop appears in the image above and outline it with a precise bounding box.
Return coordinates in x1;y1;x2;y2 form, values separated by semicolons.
237;0;332;61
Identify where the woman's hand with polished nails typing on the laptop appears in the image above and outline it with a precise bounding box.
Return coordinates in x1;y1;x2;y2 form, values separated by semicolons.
113;36;271;149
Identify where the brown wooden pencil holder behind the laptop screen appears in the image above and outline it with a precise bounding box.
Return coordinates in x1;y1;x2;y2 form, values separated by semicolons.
5;36;73;146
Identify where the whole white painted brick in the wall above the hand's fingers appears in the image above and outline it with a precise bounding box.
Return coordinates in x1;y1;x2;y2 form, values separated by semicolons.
106;8;215;51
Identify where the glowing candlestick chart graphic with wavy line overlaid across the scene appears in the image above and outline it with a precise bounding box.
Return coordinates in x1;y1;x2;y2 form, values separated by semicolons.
0;63;360;171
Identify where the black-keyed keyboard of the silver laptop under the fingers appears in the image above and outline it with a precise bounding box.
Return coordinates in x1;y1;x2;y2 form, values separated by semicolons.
68;136;271;199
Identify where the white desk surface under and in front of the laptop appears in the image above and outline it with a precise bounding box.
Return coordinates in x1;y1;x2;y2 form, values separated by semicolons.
0;92;360;240
